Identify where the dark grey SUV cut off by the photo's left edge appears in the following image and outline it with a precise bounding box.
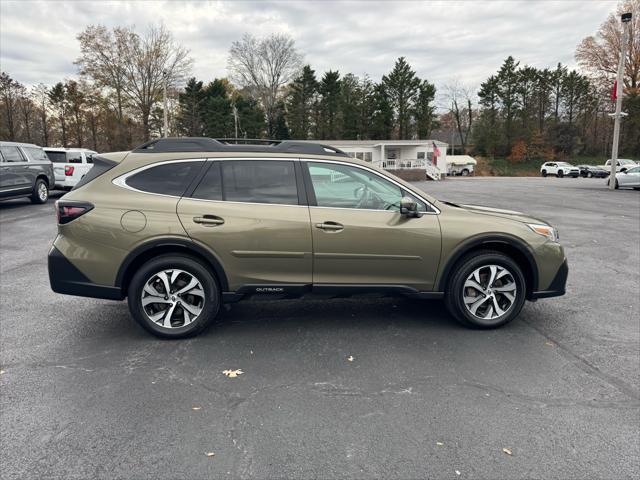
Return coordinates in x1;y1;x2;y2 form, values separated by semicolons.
0;142;55;203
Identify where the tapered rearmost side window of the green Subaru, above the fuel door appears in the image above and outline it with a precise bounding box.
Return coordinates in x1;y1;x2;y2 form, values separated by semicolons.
126;162;203;197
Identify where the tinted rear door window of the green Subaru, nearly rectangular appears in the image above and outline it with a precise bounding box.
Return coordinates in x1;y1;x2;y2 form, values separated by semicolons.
222;160;298;205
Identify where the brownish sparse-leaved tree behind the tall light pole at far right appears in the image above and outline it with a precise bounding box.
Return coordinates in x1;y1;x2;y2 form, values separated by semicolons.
576;0;640;89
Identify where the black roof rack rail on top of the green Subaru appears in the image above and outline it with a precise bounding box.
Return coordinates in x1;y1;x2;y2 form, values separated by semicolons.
132;137;348;157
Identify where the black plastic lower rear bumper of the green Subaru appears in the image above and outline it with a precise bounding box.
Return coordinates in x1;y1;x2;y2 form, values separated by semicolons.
48;247;124;300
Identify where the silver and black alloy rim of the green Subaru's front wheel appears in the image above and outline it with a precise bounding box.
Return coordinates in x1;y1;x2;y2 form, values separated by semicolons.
462;265;518;320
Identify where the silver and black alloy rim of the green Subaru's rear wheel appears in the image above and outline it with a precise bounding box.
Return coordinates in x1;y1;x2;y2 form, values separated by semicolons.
140;269;205;328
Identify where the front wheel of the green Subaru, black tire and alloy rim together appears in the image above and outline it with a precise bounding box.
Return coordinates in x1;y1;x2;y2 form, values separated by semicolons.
445;251;526;328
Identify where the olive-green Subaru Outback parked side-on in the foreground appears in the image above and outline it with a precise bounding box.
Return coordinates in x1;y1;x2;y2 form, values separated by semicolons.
49;138;568;338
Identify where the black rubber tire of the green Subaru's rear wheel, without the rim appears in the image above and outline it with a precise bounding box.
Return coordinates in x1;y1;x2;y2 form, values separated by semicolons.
128;254;221;339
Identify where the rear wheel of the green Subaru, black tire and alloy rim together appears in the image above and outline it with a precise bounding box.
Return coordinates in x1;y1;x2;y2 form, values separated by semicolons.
128;255;220;338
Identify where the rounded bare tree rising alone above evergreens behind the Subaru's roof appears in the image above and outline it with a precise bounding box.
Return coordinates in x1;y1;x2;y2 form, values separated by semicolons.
227;34;302;137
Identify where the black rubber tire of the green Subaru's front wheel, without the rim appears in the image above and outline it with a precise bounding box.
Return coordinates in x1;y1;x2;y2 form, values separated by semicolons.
444;250;526;329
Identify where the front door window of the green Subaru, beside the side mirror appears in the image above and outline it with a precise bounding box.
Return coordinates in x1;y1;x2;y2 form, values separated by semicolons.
308;163;426;212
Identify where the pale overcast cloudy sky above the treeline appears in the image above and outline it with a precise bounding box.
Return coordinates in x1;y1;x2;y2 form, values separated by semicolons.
0;0;616;107
